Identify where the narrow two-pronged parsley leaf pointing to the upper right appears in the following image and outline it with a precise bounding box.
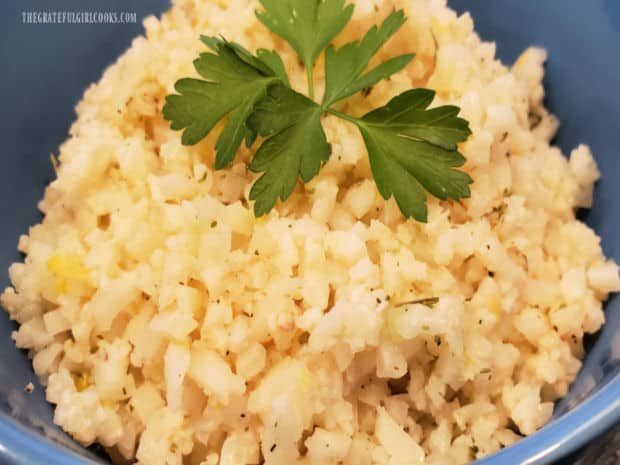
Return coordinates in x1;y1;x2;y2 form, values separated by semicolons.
323;10;414;106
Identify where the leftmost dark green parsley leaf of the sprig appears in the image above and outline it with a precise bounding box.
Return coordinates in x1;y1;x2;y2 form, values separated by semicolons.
163;36;288;169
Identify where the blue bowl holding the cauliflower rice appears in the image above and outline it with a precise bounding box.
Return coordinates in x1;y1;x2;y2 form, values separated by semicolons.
0;0;620;465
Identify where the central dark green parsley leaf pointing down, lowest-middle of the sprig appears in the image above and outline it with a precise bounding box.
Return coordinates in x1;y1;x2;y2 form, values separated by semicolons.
248;84;329;216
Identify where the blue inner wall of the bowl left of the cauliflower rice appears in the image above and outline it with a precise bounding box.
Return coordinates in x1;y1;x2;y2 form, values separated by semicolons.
0;0;170;465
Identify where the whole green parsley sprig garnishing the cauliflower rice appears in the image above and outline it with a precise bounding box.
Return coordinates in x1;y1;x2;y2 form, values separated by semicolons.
163;0;473;222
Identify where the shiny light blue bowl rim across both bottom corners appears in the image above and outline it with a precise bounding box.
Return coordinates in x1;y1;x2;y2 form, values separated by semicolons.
0;374;620;465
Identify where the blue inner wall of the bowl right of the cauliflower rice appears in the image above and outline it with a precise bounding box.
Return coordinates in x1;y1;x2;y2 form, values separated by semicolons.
448;0;620;418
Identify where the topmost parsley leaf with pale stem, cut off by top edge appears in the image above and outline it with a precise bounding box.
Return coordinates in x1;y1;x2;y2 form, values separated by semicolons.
256;0;354;99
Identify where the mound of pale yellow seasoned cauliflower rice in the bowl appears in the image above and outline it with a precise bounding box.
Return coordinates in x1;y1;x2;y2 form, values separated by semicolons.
2;0;620;465
